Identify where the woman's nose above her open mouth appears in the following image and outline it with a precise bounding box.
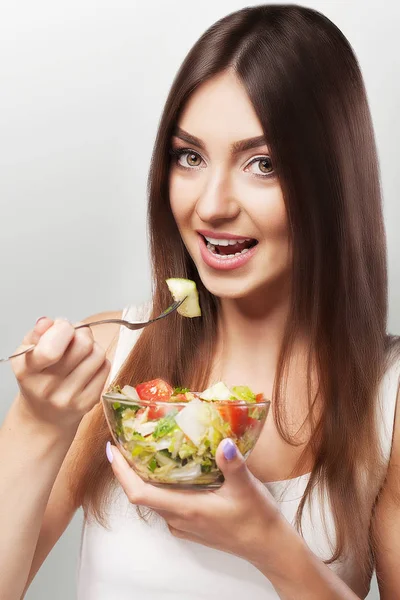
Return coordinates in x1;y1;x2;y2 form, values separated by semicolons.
196;175;240;223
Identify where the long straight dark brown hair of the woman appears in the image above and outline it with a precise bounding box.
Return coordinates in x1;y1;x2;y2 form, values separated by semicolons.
74;5;396;574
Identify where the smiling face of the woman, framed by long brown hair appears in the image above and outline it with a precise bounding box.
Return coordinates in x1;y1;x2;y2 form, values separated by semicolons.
169;72;291;298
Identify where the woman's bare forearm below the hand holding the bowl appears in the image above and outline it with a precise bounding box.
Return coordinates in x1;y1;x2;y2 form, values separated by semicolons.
254;517;360;600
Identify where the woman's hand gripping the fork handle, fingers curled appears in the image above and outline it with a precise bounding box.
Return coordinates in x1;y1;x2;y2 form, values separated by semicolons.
11;317;111;430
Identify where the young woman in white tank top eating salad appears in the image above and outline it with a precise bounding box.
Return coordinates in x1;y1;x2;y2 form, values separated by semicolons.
0;6;400;600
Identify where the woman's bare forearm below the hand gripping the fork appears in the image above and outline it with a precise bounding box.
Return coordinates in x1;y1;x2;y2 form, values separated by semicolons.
0;398;74;600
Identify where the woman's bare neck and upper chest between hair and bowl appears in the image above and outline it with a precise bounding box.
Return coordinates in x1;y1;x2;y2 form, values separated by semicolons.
209;280;319;441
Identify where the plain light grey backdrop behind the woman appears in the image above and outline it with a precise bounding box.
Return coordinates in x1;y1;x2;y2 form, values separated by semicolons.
0;0;400;600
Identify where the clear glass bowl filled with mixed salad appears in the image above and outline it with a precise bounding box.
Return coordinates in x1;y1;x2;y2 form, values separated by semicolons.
102;392;271;489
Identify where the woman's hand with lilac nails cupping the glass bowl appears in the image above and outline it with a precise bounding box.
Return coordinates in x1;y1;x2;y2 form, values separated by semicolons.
107;440;283;564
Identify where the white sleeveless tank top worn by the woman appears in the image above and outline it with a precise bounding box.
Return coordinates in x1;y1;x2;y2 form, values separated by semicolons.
77;305;400;600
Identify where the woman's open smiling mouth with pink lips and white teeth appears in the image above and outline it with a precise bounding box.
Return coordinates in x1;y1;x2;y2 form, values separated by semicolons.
198;232;258;270
